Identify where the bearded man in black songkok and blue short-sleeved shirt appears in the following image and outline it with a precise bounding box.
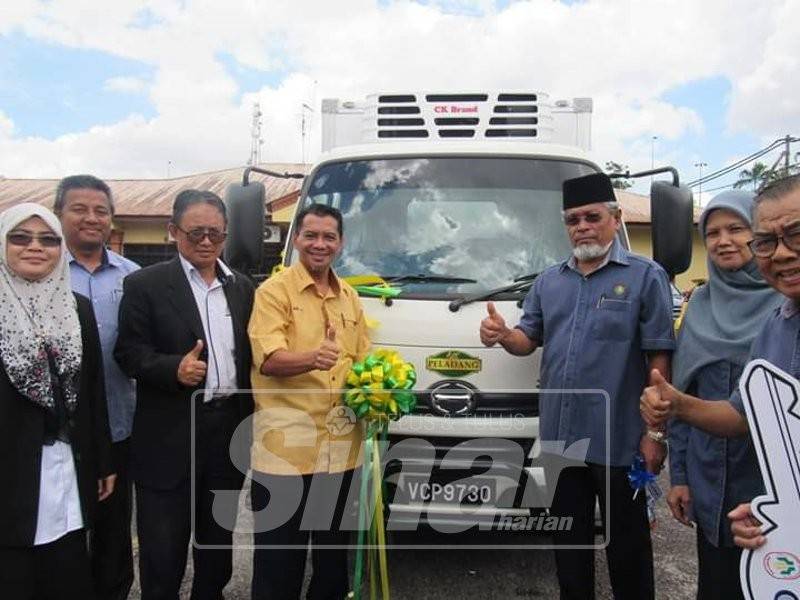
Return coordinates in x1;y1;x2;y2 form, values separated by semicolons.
480;173;674;600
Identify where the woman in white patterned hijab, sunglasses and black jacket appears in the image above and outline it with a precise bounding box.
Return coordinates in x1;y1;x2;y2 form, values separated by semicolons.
0;203;114;599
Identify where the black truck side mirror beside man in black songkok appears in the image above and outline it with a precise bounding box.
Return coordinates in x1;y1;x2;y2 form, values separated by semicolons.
650;181;694;277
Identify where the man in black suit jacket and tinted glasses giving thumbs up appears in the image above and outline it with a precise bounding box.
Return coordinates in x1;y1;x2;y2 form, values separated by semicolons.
114;190;253;600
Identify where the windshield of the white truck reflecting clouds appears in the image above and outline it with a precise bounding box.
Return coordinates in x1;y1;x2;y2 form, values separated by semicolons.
291;157;594;298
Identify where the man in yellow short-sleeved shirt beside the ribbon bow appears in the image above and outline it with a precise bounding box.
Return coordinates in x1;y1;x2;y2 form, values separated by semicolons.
248;204;369;600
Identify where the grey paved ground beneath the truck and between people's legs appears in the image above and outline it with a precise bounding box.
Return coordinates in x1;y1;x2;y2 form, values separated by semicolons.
131;476;697;600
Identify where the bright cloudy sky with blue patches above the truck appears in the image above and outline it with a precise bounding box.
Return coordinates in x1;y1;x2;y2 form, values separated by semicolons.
0;0;800;199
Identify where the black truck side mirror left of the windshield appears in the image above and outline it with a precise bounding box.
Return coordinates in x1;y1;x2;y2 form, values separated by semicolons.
224;181;265;273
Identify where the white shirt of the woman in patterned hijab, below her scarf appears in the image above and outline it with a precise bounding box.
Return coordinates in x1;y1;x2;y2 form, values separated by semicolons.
33;440;83;546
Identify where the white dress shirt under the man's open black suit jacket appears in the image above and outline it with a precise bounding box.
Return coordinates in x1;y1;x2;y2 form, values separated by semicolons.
178;255;238;402
